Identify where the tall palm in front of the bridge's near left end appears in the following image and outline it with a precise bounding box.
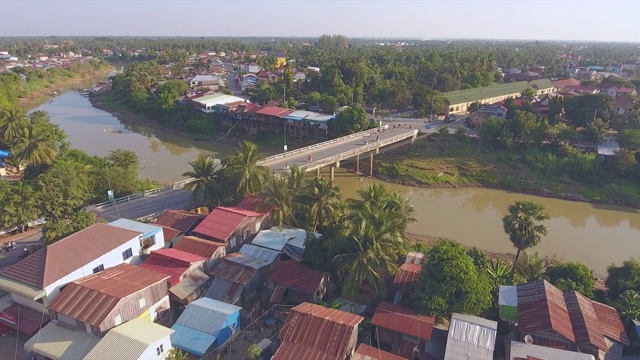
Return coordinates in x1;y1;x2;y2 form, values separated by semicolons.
224;141;271;196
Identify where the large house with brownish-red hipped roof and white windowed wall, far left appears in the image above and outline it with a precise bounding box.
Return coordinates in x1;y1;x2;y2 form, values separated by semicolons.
0;224;148;331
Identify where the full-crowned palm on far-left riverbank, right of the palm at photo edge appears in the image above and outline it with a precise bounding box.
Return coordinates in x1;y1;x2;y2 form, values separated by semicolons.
13;117;58;166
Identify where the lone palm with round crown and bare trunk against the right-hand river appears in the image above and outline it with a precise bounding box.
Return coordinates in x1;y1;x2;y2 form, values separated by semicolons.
502;199;549;270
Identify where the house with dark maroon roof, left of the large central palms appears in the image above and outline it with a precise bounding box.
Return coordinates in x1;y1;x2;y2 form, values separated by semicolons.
267;260;329;304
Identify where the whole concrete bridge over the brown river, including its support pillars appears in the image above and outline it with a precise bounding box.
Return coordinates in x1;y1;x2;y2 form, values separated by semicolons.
258;125;418;181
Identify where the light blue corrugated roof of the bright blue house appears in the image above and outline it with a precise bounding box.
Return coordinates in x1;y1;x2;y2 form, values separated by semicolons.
176;297;242;335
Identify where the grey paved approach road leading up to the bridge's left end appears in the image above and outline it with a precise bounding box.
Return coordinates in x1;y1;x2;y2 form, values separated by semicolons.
94;189;196;221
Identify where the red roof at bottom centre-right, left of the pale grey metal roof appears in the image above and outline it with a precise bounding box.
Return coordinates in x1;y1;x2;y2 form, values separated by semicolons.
371;301;435;341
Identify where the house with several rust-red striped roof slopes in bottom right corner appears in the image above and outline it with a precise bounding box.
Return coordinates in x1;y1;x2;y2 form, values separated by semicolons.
517;280;629;360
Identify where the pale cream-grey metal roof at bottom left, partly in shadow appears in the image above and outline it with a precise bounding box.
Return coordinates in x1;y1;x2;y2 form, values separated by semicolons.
24;323;100;360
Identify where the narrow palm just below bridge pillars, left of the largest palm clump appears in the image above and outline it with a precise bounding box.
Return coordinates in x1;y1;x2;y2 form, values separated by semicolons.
307;178;341;232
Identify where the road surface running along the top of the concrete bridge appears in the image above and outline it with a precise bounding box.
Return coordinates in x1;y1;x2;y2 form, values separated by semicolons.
262;124;424;174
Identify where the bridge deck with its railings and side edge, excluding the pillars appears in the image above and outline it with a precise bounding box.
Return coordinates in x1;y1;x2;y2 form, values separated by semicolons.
260;127;418;174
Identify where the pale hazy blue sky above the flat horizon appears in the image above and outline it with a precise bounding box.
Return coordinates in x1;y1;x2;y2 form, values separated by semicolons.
5;0;640;42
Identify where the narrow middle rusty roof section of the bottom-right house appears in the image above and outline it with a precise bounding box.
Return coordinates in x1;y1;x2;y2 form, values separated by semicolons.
564;291;609;351
